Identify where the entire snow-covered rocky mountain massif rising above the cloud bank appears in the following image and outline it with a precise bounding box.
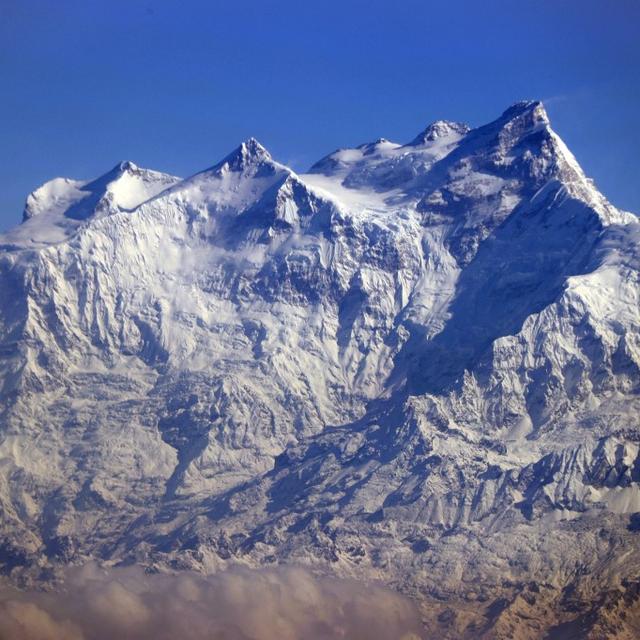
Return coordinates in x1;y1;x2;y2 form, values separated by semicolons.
0;102;640;638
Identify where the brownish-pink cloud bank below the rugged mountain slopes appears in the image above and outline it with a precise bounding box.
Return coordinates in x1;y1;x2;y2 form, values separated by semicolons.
0;565;421;640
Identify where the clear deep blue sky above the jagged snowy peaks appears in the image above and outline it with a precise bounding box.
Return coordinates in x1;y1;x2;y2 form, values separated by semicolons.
0;0;640;229
